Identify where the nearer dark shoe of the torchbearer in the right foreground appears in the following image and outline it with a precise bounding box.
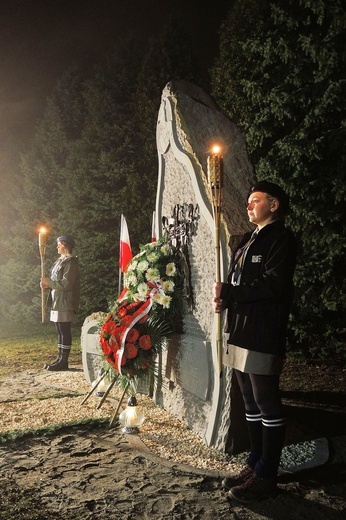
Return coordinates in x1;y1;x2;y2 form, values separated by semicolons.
228;473;280;504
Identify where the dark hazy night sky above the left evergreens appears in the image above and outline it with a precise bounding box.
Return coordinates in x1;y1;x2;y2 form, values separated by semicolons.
0;0;230;150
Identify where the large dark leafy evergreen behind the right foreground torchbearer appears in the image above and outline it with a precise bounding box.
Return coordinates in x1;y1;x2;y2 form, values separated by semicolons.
212;0;346;359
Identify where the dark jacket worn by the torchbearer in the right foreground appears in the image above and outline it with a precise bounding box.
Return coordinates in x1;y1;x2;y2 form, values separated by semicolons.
220;221;296;356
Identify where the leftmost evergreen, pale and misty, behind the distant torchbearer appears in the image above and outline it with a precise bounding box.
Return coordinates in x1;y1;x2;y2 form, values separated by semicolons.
0;70;88;322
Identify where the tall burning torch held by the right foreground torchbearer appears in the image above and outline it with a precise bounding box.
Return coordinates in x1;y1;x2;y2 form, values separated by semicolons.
207;145;223;377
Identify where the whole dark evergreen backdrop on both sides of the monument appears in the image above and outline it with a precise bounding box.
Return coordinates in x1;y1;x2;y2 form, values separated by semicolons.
0;0;346;361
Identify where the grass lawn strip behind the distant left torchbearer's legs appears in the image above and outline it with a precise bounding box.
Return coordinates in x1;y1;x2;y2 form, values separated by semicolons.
0;322;82;380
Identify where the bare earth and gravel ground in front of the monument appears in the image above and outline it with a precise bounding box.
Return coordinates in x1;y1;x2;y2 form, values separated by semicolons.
0;367;346;520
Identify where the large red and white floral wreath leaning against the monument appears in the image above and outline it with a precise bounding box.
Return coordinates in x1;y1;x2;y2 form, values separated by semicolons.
100;238;186;388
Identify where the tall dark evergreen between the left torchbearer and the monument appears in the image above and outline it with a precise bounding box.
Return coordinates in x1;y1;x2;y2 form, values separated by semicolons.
58;42;146;316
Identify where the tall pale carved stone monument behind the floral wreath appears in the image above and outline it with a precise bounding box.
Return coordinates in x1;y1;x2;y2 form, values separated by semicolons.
153;80;254;451
